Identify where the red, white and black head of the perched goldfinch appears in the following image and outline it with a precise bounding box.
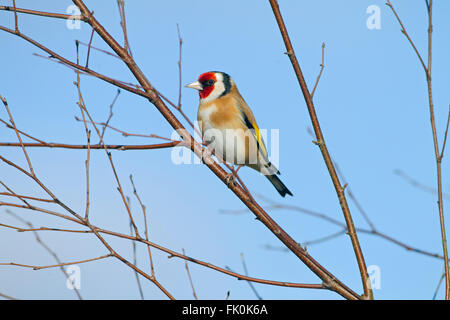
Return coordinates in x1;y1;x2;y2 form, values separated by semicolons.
186;71;234;102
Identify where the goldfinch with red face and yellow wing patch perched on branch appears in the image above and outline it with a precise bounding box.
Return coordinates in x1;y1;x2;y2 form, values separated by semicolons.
186;71;293;197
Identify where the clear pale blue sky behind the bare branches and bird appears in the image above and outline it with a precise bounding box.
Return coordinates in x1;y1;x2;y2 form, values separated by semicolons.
0;0;450;299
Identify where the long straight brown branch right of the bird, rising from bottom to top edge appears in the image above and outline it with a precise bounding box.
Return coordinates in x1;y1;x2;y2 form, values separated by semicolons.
269;0;373;299
